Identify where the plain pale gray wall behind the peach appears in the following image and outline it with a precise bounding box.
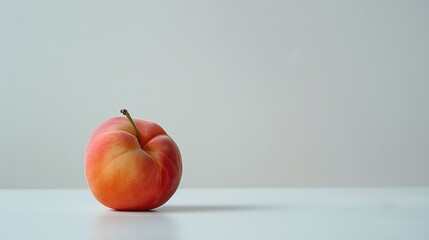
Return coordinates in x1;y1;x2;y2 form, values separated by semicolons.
0;0;429;188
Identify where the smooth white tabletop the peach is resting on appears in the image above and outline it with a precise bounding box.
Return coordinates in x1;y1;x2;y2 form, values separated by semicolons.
0;188;429;240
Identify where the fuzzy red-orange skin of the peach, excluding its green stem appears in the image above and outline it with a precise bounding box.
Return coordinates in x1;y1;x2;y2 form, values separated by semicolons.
85;114;182;210
